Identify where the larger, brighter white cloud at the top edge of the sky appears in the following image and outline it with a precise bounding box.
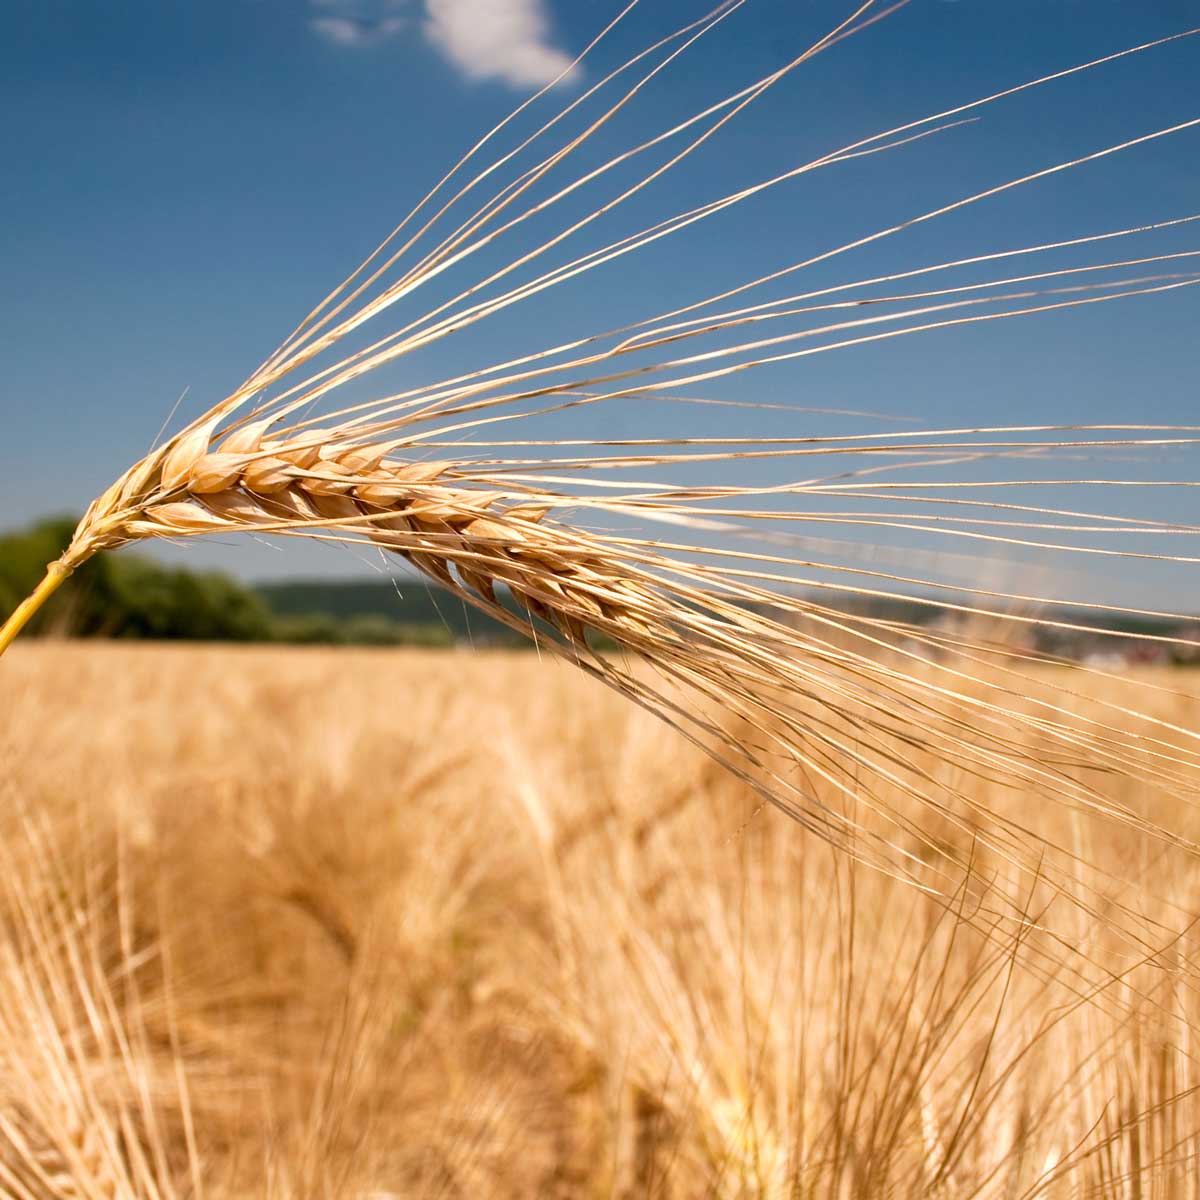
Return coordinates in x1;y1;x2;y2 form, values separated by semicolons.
425;0;571;88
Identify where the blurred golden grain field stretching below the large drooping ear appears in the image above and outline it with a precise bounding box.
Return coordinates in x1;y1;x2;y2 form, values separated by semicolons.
7;643;1200;1200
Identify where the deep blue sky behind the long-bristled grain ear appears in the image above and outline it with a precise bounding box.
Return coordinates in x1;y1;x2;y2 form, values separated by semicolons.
0;0;1200;595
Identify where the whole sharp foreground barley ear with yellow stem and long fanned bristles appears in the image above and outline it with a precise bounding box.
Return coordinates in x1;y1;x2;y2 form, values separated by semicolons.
0;0;1200;953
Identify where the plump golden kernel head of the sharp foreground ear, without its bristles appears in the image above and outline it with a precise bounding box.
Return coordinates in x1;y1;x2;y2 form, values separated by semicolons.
52;424;655;662
